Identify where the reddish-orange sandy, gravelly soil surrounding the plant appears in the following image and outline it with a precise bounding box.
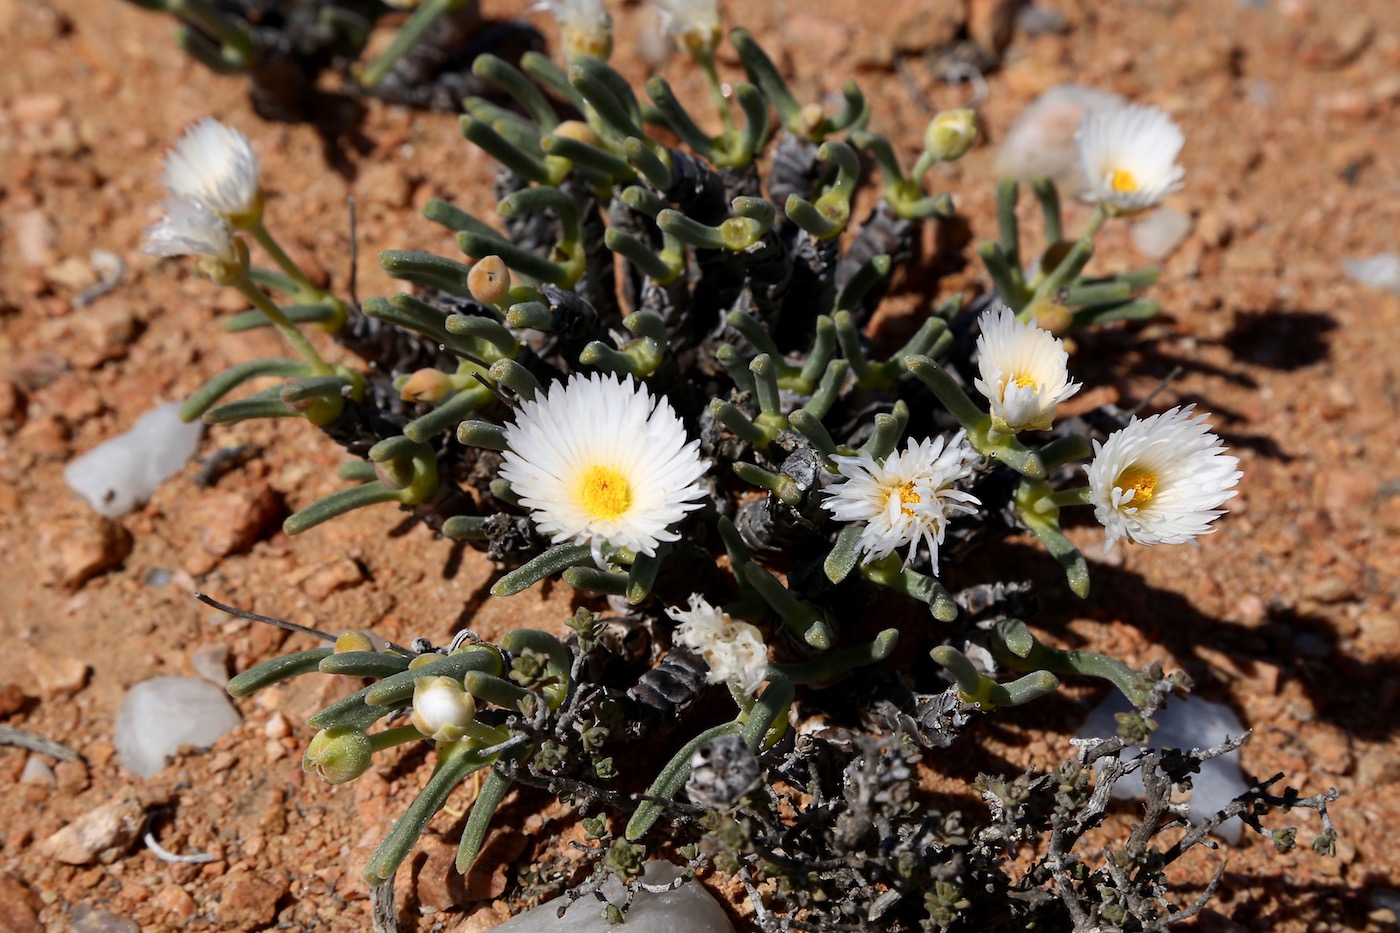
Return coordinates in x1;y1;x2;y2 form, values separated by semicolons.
0;0;1400;930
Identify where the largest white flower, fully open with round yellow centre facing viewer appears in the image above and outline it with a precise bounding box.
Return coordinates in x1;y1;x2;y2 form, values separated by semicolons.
500;373;708;556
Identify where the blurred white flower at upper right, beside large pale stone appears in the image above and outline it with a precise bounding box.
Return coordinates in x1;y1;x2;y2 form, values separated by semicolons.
1078;104;1186;214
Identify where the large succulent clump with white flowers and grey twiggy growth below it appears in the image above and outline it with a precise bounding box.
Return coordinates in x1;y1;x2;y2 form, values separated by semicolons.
139;0;1336;930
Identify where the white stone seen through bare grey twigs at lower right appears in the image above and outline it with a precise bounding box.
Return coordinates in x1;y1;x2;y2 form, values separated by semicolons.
1077;691;1249;845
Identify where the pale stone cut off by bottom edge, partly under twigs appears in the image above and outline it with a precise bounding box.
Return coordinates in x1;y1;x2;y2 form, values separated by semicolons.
496;862;734;933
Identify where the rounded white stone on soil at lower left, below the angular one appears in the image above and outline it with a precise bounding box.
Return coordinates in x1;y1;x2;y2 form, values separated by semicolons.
112;677;239;778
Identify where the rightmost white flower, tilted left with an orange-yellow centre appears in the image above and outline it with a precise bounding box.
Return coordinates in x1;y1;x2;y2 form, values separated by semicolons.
1085;405;1243;552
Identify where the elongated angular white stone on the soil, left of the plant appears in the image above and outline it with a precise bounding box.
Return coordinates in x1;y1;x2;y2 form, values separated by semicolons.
63;402;204;518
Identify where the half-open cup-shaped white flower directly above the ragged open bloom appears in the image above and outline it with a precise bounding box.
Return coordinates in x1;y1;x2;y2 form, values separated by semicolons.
973;304;1079;434
